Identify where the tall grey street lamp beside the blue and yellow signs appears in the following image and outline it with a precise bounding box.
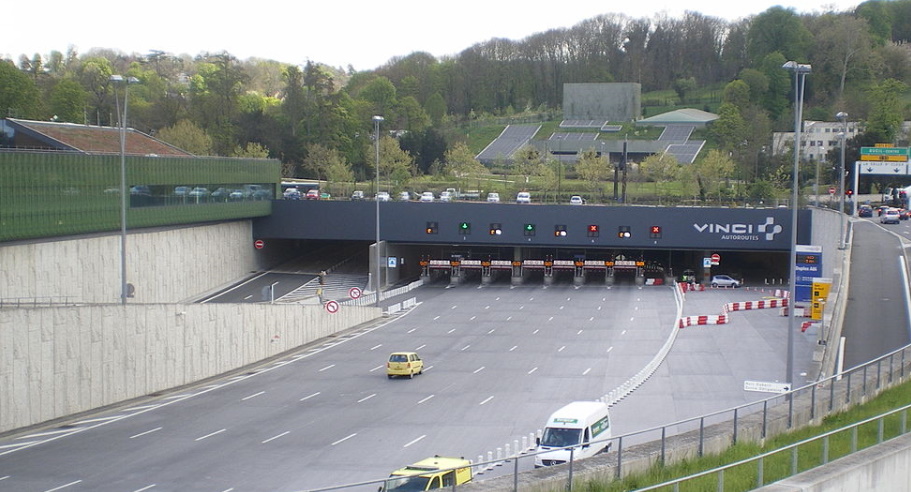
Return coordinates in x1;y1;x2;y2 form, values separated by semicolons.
781;60;812;388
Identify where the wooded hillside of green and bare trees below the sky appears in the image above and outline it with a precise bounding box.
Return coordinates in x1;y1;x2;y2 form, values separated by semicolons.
0;0;911;199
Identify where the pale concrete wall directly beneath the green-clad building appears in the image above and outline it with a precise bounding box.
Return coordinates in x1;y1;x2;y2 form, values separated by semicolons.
0;221;258;303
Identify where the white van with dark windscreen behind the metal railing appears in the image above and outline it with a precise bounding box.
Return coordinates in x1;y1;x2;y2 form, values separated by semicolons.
535;401;611;468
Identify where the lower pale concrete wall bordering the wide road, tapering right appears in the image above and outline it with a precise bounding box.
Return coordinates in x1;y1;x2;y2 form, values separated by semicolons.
0;304;381;432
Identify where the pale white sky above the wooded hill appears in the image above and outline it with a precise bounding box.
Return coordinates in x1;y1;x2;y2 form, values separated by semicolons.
0;0;861;70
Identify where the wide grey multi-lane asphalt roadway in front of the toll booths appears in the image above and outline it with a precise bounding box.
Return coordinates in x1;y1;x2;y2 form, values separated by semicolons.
0;284;815;492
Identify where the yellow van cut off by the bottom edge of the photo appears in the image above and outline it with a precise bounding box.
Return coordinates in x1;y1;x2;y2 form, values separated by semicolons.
380;456;471;492
